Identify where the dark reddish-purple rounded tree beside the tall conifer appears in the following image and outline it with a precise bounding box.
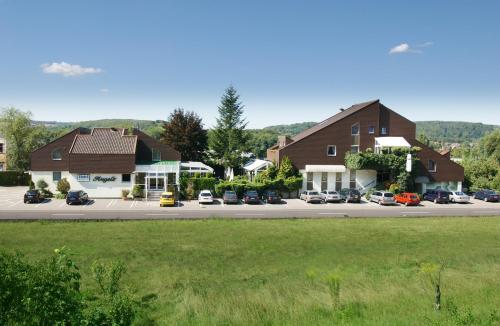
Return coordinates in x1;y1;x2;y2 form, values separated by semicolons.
161;108;208;161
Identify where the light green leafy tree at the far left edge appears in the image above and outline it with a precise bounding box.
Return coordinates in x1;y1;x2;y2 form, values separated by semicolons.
0;108;47;171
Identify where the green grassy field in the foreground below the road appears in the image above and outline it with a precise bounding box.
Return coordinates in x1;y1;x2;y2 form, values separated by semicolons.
0;218;500;325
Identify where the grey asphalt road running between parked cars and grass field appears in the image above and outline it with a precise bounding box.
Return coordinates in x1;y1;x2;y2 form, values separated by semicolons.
0;204;500;220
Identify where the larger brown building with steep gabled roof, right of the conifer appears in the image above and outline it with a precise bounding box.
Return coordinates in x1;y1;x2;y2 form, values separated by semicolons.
267;100;464;192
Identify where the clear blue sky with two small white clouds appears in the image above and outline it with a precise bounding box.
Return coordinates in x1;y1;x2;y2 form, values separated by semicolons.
0;0;500;127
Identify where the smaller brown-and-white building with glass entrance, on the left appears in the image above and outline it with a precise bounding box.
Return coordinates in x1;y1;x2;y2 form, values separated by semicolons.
30;128;181;198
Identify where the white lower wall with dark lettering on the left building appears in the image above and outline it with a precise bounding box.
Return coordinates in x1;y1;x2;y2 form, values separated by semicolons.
31;171;135;198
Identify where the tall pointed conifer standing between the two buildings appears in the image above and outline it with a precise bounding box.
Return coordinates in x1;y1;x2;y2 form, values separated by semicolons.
209;86;248;174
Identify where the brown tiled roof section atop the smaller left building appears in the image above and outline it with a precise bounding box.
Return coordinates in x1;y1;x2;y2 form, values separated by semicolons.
69;128;137;154
